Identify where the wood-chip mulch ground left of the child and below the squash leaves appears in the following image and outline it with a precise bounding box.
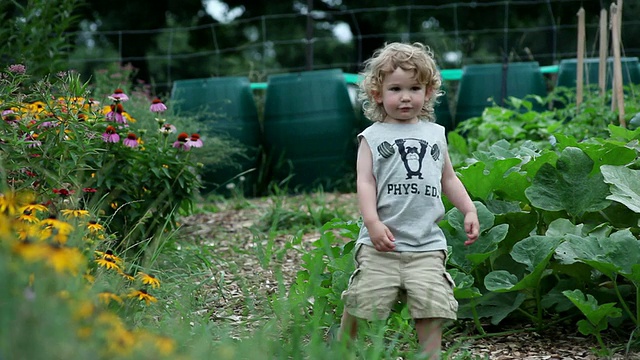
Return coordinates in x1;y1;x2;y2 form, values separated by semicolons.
183;194;640;360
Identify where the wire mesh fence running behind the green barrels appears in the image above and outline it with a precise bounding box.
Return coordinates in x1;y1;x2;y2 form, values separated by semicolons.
69;0;640;87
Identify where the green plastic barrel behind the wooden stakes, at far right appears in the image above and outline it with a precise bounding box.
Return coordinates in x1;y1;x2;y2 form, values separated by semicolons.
556;57;640;89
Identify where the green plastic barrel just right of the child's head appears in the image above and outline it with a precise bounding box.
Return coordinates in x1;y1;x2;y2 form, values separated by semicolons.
455;61;547;123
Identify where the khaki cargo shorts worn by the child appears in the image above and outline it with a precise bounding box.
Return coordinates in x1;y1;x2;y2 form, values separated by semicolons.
342;244;458;320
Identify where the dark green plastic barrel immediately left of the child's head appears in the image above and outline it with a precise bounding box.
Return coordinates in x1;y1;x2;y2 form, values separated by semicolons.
263;69;356;191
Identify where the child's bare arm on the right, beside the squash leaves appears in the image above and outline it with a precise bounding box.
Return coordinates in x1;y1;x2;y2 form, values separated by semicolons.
442;151;480;245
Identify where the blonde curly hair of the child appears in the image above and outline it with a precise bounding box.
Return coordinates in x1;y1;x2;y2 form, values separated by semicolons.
358;42;444;122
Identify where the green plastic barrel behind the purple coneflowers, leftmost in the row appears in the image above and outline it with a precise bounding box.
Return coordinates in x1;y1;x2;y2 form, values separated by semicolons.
171;77;261;195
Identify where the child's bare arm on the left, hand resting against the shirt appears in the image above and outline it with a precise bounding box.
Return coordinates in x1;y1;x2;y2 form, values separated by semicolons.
356;138;396;251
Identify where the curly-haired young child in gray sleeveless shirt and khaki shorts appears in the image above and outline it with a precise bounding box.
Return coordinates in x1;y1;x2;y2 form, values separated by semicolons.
338;43;479;359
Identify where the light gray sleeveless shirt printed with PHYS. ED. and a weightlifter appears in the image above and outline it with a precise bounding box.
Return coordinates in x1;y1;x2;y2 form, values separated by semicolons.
357;121;447;252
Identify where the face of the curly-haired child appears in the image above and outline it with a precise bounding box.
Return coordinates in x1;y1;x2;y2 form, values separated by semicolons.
375;68;428;123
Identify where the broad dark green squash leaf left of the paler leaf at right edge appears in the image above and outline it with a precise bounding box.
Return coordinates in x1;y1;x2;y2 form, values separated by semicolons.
525;147;610;217
